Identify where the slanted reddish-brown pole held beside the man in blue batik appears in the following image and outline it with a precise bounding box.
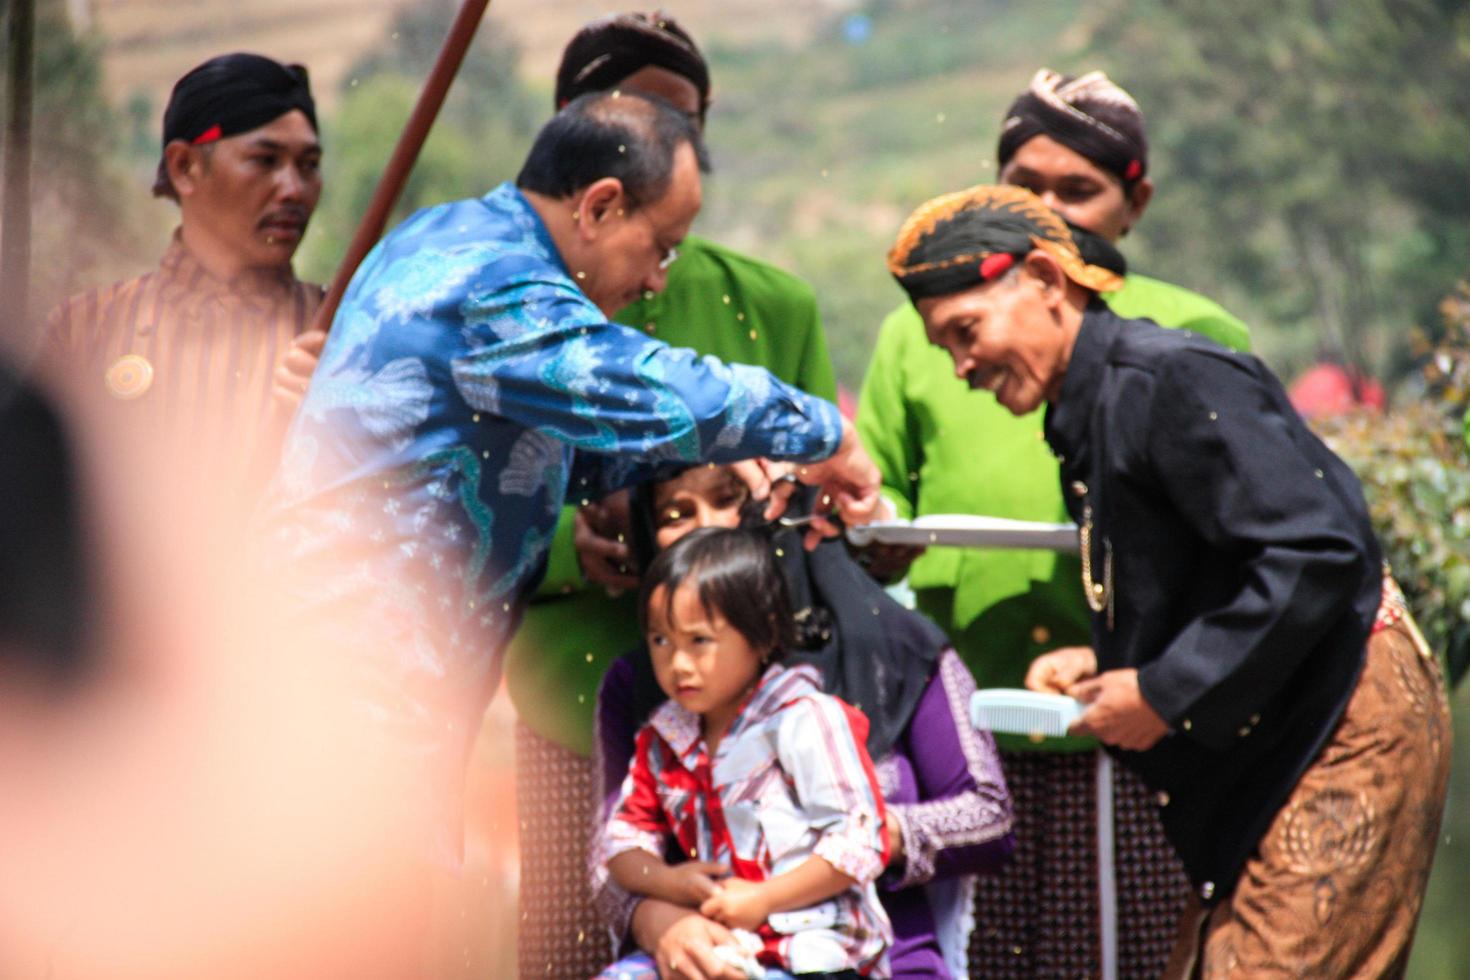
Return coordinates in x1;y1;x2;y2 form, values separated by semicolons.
312;0;490;337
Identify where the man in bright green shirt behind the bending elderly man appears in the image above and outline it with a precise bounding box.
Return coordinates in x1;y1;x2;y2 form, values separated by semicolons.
857;69;1250;977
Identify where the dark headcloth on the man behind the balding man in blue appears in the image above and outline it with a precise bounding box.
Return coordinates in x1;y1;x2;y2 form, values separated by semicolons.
556;10;710;123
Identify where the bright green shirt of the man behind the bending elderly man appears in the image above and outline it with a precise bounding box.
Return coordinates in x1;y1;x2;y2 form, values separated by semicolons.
857;275;1251;749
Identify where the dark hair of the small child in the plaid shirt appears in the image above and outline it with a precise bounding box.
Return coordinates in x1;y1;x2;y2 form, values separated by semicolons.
638;527;797;658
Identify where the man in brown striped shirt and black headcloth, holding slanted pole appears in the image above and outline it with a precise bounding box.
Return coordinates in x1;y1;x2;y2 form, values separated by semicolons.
43;53;323;505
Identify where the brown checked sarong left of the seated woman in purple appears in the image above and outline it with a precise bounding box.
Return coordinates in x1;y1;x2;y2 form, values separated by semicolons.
516;723;613;980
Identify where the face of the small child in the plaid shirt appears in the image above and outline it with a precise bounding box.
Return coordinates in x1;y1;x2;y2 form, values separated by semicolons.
648;582;766;738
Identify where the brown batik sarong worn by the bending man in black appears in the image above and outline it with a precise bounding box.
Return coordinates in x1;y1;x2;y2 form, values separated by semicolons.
1166;583;1451;980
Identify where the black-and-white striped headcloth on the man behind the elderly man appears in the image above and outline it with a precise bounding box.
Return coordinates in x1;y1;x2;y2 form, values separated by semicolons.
998;68;1148;185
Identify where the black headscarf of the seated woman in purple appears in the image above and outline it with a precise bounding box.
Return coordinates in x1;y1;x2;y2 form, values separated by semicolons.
632;483;950;760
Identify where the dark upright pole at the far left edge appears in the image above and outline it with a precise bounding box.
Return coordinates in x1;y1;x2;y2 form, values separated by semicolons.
0;0;35;329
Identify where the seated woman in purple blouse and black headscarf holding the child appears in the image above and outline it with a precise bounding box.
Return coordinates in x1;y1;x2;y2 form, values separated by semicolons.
595;466;1014;980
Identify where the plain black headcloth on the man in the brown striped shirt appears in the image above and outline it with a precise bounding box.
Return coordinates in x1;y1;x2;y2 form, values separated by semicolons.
163;53;316;145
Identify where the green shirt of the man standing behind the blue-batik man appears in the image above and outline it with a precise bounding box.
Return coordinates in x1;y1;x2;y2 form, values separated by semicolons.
506;238;836;755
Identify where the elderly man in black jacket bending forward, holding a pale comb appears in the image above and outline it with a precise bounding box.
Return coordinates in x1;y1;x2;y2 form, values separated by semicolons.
889;187;1449;977
